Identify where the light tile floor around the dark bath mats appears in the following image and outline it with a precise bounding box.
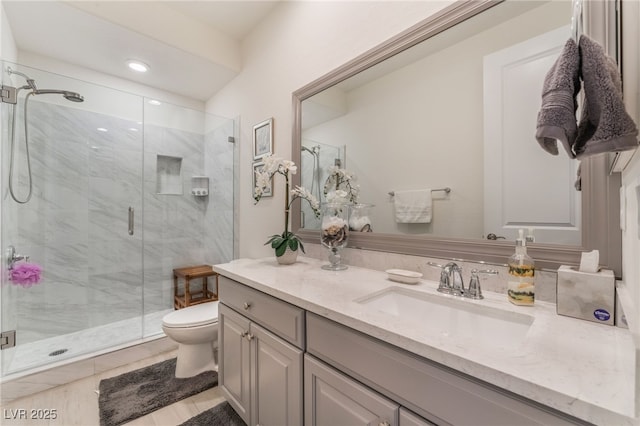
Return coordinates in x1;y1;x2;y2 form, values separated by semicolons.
0;351;224;426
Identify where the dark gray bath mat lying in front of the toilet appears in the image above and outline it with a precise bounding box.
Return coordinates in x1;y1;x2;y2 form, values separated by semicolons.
98;358;218;426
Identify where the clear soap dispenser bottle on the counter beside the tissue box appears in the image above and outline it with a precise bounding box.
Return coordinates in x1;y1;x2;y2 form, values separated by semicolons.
507;229;535;306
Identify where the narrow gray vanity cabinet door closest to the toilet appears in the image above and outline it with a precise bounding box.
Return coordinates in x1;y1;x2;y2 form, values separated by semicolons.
218;303;251;424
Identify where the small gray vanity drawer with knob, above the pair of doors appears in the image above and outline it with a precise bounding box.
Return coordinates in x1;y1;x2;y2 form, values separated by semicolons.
218;276;305;349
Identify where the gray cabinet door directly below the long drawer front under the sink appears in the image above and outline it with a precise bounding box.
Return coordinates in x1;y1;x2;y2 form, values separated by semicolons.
304;355;399;426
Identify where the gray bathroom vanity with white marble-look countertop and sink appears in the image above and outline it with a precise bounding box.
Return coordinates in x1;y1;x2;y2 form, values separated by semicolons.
215;258;636;426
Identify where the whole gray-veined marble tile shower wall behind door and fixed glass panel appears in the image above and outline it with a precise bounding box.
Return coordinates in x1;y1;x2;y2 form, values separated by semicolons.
3;101;233;343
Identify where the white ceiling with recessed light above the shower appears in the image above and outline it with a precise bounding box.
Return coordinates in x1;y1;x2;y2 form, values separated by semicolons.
2;0;279;101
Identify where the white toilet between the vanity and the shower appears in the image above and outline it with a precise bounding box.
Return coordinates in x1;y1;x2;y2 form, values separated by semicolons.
162;301;218;378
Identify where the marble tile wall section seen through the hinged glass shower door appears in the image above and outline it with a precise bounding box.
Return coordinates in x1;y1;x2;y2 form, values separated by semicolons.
8;101;142;343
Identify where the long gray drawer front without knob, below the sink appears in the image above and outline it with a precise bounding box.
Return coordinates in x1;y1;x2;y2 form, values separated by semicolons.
307;313;585;425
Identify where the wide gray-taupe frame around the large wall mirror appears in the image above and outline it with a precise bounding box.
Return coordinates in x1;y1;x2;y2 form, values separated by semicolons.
291;0;622;278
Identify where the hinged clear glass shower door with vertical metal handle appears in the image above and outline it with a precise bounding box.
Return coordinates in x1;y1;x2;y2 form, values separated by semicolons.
0;62;143;376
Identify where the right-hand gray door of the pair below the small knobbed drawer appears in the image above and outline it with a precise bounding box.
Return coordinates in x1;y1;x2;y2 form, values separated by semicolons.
250;323;303;426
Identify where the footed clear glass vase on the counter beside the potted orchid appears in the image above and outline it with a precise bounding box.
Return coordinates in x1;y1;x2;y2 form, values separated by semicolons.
320;203;349;271
